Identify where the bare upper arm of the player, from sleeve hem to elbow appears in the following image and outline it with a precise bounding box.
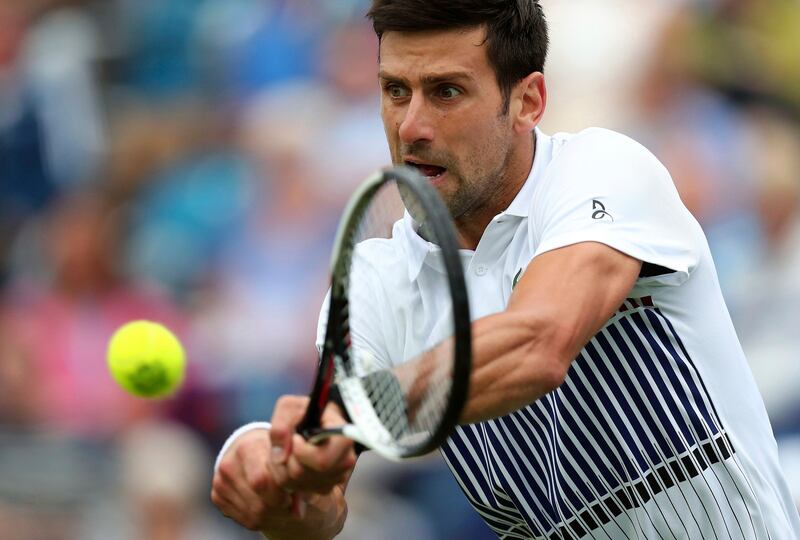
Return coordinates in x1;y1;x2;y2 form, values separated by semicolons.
507;242;642;368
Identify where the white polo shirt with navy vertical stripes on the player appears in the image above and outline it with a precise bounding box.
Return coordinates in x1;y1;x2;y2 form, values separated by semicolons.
318;129;800;539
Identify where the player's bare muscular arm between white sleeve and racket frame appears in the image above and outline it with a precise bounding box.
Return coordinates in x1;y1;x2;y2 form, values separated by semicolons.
461;242;642;423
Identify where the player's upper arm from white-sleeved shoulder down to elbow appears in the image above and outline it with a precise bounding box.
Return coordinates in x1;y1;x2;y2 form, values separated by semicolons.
508;130;701;382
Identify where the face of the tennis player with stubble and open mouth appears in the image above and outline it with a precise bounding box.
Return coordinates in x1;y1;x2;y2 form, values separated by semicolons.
379;27;513;220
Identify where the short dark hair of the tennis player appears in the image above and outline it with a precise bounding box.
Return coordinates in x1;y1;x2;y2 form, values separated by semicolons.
367;0;549;109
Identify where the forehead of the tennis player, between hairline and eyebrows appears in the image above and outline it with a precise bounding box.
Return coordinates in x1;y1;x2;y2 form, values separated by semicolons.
380;27;492;78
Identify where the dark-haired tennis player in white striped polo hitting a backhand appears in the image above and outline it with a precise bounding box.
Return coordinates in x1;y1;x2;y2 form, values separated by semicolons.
212;0;800;540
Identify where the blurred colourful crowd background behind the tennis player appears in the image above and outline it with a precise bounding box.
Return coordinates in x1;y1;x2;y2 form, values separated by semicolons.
0;0;800;540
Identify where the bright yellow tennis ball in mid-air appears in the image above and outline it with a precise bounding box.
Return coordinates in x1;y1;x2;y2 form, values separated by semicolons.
108;321;186;398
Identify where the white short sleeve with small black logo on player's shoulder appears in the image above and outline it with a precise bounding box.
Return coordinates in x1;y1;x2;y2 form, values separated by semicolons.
529;128;700;285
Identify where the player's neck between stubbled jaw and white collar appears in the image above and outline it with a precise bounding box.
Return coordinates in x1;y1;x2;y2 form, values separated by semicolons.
455;133;536;250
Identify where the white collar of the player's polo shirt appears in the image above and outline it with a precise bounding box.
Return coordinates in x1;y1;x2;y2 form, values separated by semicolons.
392;127;552;281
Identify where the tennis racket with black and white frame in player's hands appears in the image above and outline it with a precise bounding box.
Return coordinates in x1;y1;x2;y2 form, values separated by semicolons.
297;167;471;460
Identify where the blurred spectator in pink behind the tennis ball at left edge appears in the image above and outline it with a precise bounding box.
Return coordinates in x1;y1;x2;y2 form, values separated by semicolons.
3;192;182;436
